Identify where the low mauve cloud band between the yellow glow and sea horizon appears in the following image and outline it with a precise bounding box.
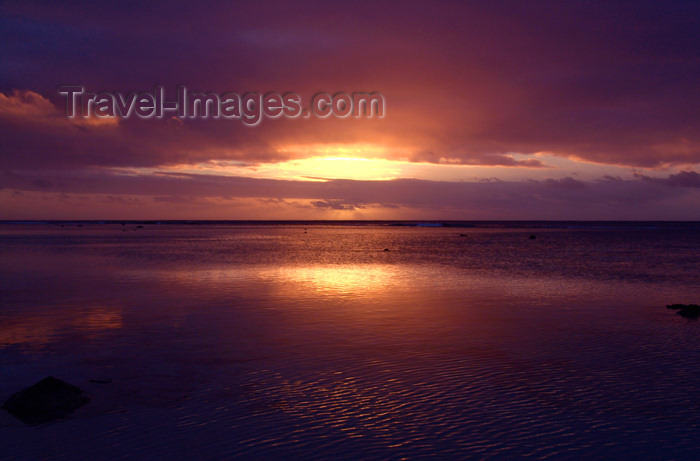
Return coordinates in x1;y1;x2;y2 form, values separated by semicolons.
0;172;700;220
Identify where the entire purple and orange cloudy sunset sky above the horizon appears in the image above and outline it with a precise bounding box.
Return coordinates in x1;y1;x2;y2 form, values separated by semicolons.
0;1;700;220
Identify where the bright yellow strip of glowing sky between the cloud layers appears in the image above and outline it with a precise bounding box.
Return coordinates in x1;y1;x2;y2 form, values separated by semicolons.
121;143;660;186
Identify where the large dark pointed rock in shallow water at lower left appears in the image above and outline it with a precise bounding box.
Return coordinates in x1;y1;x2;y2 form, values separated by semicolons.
2;376;90;424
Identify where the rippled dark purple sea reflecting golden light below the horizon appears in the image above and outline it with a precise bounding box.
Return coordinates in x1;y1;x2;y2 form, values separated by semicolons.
0;222;700;460
